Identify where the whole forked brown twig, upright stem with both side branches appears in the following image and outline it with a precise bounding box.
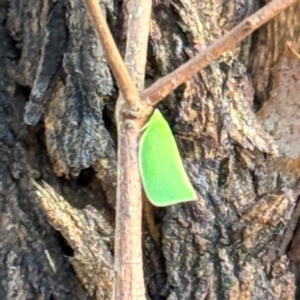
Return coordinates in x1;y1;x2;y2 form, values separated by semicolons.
82;0;297;300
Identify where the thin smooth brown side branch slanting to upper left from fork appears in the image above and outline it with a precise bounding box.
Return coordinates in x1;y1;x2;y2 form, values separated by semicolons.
85;0;139;107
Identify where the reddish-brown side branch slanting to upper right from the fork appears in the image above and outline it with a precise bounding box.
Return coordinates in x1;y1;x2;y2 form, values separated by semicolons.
142;0;297;106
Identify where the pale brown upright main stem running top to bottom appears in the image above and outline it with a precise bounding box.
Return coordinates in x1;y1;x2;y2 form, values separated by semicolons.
113;0;152;300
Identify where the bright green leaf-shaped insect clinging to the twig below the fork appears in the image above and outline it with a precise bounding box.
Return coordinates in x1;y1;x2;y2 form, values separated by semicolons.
139;109;197;206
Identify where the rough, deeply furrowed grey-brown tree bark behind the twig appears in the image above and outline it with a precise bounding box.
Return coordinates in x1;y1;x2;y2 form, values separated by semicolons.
0;0;300;300
